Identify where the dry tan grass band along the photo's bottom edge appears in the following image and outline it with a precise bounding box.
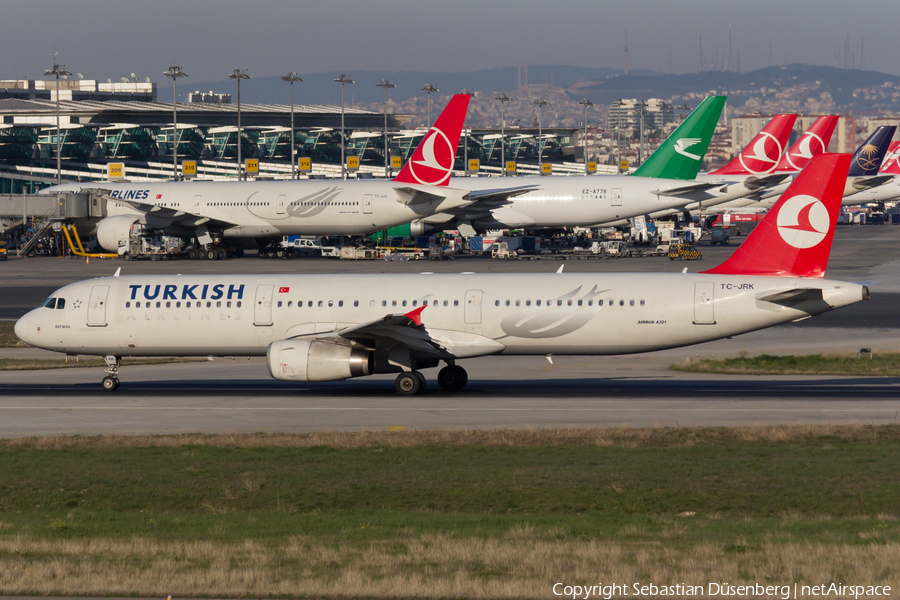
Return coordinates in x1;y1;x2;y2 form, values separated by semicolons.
0;530;900;598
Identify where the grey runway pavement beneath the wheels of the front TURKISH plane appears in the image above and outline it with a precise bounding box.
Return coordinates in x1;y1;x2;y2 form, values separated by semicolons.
0;328;900;437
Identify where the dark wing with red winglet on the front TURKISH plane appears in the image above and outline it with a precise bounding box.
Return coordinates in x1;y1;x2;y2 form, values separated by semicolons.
325;306;451;358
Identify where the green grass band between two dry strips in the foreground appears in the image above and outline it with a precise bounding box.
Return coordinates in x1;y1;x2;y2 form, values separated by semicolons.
0;427;900;536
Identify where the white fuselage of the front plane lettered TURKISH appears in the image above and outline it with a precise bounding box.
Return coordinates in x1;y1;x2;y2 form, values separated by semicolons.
16;273;866;358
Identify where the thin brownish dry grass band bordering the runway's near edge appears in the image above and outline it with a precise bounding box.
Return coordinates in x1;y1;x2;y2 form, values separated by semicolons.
0;424;900;450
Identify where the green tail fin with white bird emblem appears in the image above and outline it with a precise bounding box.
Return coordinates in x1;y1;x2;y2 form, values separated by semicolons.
632;96;727;179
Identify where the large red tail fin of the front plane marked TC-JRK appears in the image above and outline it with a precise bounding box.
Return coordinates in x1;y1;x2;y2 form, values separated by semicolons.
704;154;850;277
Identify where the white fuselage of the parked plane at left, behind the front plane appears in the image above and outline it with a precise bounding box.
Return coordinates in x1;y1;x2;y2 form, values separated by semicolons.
43;179;468;237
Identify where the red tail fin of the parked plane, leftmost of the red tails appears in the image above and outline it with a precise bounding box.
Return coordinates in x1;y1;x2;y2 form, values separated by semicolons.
394;94;470;186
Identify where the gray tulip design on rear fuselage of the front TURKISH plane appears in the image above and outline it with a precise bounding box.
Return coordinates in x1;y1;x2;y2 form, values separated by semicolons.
498;285;609;339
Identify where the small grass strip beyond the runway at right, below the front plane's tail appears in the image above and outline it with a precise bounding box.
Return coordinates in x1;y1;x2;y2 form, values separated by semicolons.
670;353;900;377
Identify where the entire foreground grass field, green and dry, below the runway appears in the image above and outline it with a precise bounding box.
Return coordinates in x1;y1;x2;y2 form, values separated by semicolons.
0;425;900;598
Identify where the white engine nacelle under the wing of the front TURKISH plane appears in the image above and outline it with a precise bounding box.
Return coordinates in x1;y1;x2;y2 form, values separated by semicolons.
266;339;375;381
